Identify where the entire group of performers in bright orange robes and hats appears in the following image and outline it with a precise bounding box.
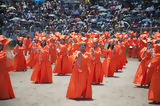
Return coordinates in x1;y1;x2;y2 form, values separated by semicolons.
0;32;160;103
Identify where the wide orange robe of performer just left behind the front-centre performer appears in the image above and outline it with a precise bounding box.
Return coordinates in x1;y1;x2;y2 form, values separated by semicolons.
53;44;72;74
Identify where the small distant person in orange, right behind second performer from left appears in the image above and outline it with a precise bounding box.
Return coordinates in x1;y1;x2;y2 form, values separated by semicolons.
23;33;31;55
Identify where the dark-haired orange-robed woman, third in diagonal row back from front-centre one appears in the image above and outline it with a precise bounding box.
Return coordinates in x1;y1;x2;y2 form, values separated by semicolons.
102;41;116;77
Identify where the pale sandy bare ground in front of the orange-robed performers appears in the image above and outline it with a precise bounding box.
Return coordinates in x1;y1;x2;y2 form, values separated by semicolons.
0;59;156;106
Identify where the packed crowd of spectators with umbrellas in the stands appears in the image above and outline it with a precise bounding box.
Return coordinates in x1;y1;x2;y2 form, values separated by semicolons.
0;0;160;37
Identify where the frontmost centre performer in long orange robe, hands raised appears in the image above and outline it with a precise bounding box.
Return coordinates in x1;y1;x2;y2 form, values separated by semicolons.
66;42;92;99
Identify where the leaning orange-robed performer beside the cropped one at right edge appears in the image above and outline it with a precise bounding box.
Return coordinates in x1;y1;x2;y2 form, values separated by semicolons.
133;42;153;86
